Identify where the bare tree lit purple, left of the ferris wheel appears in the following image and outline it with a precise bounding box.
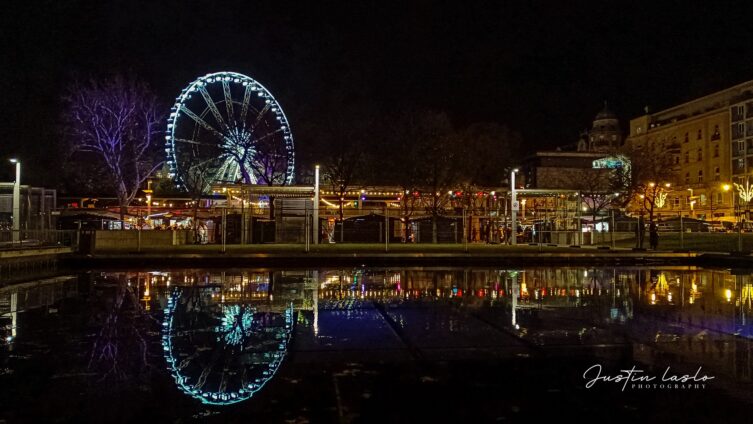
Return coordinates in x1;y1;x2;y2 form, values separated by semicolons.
63;76;163;222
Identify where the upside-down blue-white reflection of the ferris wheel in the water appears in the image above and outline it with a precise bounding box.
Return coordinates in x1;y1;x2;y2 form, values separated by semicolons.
162;288;293;405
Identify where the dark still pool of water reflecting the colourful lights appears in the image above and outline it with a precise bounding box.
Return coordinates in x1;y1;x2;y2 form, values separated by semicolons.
0;268;753;422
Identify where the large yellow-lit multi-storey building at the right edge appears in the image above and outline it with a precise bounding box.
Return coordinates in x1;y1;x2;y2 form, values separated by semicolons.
626;81;753;220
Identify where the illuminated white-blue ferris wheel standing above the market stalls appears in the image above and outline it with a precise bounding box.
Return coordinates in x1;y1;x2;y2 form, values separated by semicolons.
165;72;295;192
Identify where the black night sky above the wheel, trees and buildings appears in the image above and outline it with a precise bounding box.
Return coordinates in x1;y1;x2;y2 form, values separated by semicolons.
0;0;753;185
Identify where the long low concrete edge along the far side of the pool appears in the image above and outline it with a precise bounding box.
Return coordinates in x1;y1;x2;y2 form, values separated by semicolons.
64;247;708;269
